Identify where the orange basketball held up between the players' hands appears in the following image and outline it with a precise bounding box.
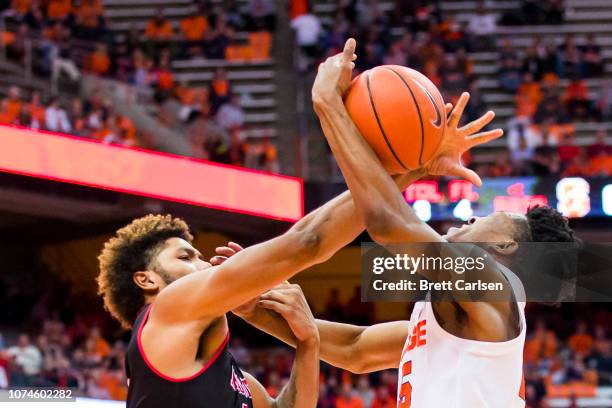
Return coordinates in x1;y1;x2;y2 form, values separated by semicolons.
344;65;446;174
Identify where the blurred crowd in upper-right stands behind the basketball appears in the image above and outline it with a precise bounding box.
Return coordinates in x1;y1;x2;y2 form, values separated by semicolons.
292;0;612;177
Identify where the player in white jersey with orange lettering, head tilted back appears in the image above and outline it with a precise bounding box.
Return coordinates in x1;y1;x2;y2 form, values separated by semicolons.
224;39;576;408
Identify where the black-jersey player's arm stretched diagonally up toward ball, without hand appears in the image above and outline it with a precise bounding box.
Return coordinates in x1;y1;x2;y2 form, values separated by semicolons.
152;167;422;322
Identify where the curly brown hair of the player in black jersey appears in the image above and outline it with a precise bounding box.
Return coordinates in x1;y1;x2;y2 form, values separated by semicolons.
97;214;193;329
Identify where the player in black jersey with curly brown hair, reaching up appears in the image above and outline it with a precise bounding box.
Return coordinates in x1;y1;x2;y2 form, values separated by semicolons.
98;95;450;408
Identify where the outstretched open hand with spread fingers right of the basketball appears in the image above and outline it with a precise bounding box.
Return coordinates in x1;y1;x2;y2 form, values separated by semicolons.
424;92;504;187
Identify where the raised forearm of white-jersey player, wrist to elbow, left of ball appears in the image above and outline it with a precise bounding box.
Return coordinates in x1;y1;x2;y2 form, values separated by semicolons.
314;96;424;228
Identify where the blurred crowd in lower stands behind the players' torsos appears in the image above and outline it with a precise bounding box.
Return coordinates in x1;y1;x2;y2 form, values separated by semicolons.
0;288;612;408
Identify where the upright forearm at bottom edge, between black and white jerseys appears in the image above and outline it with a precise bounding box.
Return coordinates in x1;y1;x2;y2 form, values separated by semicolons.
275;339;319;408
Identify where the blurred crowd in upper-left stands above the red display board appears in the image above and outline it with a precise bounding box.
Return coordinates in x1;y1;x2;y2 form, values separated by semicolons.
2;0;279;172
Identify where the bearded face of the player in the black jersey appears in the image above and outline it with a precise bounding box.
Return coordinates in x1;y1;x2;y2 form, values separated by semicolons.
157;238;212;284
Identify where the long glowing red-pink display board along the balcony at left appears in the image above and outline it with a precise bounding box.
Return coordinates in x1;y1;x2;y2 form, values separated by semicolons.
0;126;304;221
